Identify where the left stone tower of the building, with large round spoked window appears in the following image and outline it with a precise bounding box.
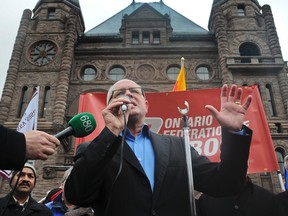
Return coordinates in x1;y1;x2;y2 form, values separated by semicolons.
0;0;84;133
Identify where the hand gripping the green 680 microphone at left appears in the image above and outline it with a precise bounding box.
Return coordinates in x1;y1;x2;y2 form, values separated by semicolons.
24;130;60;160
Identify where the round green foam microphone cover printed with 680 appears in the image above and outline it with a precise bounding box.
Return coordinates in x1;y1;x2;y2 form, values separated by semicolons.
68;112;96;137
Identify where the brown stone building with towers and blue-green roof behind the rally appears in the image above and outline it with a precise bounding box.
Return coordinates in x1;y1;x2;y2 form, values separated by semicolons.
0;0;288;199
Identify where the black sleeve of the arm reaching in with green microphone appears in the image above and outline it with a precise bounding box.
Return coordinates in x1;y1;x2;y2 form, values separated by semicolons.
0;125;26;170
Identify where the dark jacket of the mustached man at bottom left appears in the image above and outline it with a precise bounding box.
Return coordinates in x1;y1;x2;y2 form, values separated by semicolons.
0;193;53;216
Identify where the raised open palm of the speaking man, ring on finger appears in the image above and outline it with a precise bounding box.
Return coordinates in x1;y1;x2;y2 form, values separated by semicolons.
205;84;252;132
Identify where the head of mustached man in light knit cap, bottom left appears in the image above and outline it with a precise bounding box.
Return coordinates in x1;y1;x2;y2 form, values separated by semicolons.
10;163;37;198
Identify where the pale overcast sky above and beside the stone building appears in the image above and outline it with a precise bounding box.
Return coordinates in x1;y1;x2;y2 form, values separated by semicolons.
0;0;288;97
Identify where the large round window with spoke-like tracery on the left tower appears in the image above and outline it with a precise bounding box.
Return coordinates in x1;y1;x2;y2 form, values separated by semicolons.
30;41;57;66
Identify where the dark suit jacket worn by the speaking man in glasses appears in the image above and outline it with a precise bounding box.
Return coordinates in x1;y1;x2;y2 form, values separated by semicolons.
65;128;252;216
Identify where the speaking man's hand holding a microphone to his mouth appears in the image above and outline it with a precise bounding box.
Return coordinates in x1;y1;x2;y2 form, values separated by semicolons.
102;97;131;136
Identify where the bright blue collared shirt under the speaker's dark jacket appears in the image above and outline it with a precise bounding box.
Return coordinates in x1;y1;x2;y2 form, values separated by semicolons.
125;125;155;191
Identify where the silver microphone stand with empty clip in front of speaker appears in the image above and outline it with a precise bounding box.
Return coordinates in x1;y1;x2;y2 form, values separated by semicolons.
178;101;196;216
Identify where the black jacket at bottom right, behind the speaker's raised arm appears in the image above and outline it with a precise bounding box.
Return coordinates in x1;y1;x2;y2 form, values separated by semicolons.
198;181;287;216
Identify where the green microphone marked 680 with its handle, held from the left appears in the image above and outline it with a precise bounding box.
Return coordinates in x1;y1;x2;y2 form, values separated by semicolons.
54;112;96;140
